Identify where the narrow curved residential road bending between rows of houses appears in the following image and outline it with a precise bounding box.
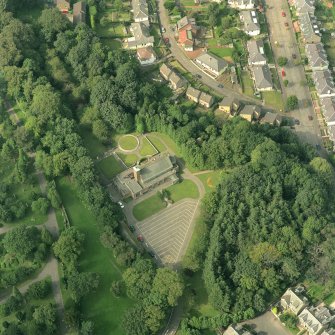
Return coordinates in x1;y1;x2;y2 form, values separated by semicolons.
158;0;262;105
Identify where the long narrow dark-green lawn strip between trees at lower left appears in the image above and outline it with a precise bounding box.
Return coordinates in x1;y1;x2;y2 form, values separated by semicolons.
57;178;133;335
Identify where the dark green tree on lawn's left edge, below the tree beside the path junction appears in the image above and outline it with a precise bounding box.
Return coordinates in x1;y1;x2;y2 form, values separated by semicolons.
68;271;99;302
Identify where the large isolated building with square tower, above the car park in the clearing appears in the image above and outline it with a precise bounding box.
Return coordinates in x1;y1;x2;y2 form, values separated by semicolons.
113;156;179;199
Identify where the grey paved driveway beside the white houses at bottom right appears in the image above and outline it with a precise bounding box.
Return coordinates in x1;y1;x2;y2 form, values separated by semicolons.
243;311;292;335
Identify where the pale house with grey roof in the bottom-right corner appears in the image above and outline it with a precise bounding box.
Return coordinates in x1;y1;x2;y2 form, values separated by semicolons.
298;306;335;335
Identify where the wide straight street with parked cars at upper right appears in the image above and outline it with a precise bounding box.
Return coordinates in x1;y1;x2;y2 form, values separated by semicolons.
266;0;322;146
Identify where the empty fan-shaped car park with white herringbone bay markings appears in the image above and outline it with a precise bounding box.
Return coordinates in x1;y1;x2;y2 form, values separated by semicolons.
135;199;198;264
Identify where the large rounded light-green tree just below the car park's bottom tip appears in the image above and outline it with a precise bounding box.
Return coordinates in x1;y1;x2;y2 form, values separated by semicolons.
152;268;184;306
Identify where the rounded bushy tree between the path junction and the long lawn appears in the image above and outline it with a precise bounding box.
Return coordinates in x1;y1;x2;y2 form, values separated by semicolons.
53;227;85;268
